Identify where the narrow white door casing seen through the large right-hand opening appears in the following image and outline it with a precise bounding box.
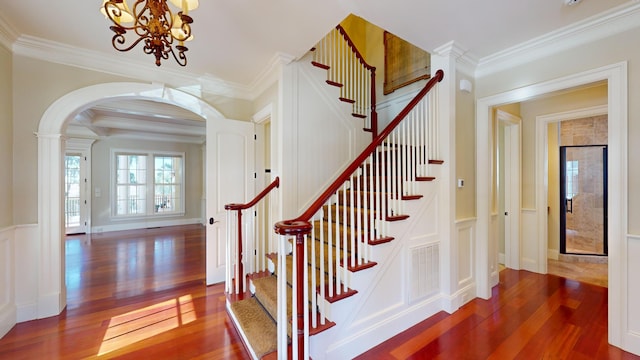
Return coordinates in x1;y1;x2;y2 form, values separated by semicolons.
496;110;522;270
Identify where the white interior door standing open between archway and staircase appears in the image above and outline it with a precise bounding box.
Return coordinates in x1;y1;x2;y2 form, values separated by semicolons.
206;120;255;285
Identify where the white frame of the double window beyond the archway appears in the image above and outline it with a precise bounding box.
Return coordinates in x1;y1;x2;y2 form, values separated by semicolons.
109;149;187;220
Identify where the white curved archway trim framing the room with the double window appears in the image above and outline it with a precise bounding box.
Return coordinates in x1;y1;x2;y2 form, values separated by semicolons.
35;82;225;318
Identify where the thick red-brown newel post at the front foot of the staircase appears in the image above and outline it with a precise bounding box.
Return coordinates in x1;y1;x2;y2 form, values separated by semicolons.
274;220;313;359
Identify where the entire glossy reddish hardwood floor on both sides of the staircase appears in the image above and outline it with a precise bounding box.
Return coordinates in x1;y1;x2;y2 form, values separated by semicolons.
0;226;640;359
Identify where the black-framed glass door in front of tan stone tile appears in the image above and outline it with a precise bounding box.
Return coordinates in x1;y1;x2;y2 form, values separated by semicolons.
560;145;607;255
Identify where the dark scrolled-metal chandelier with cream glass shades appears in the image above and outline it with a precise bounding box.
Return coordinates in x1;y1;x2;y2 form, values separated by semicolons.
101;0;198;66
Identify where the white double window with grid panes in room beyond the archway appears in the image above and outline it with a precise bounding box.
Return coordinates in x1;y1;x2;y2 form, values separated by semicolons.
114;152;184;217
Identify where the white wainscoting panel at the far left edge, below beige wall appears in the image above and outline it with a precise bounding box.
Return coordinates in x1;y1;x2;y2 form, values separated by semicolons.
0;228;16;338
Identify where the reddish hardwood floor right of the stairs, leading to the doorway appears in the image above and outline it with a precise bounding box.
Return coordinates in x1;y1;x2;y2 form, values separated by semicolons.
357;269;640;360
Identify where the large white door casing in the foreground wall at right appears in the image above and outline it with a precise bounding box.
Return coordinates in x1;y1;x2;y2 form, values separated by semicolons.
476;62;631;348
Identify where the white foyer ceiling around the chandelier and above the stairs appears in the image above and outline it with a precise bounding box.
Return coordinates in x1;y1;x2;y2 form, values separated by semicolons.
0;0;637;141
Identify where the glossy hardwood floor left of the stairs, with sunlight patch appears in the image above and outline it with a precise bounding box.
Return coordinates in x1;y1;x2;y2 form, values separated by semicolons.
0;225;249;359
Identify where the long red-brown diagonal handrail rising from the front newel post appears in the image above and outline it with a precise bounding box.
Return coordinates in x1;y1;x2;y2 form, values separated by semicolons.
292;70;444;226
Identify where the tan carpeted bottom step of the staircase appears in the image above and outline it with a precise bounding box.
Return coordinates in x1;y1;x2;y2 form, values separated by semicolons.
230;297;278;358
